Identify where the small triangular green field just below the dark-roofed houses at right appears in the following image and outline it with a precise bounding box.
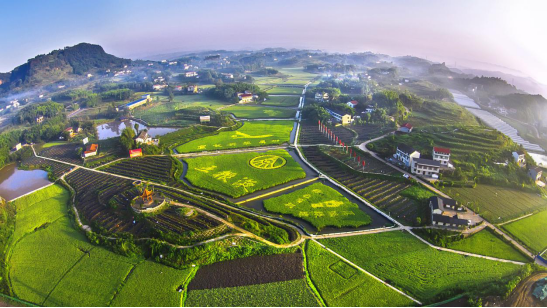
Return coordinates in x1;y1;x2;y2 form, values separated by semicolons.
447;229;530;263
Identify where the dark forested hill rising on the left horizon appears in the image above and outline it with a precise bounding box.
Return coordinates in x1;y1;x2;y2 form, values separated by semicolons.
0;43;131;91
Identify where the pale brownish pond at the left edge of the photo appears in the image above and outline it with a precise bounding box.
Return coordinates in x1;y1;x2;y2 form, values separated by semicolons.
0;164;51;200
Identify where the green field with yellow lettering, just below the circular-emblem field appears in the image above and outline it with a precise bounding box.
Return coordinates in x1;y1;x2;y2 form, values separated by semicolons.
264;183;372;231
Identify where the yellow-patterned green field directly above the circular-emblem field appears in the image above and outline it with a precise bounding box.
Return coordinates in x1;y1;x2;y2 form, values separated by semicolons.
176;121;294;153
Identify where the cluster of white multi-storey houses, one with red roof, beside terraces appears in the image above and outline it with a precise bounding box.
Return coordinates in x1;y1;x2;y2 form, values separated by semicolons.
394;144;452;179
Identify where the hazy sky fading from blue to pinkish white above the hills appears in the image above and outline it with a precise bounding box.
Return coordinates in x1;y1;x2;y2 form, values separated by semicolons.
0;0;547;84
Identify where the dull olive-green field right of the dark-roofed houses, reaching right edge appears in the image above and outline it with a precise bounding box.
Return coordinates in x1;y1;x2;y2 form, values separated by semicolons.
444;184;547;223
